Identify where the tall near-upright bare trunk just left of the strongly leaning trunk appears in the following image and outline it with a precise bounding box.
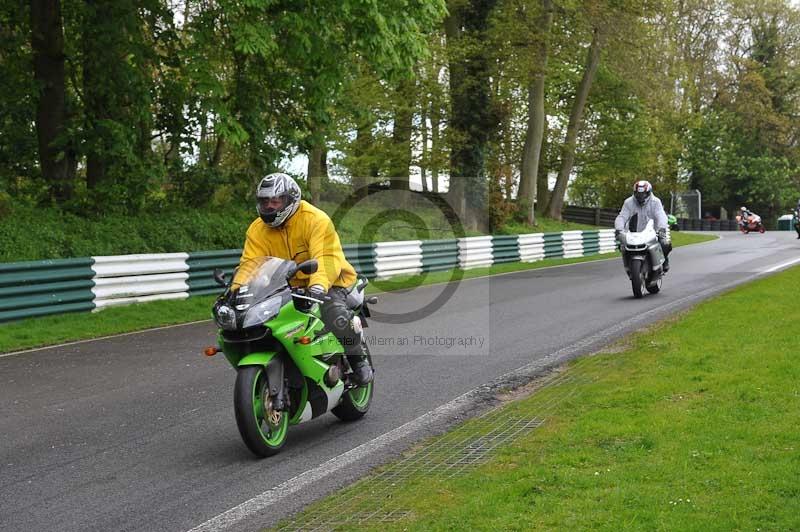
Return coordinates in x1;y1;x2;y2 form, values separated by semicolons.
517;0;553;225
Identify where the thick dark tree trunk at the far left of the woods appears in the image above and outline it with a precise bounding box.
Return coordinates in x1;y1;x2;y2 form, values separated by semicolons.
30;0;76;204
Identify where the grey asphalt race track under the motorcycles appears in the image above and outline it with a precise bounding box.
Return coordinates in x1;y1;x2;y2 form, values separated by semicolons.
0;232;800;531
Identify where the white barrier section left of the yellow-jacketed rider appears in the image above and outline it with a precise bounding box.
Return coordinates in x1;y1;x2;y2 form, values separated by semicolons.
92;253;189;310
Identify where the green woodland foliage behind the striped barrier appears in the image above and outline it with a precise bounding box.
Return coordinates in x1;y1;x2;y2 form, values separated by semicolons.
0;0;800;249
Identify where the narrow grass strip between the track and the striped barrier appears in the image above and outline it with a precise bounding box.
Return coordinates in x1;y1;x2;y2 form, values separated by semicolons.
0;233;714;353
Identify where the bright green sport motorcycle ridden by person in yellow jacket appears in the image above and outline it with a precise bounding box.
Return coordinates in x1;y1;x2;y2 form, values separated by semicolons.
205;257;377;457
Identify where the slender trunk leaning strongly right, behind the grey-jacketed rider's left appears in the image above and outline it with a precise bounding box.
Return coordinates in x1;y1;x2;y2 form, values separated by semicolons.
547;28;601;220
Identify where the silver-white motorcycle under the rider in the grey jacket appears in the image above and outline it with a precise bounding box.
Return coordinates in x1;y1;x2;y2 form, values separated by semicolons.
619;220;665;299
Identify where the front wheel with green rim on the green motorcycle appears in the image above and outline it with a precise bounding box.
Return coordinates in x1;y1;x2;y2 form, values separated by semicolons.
233;366;289;457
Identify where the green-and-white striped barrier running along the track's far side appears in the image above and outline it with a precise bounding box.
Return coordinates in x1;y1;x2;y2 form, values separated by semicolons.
0;229;616;322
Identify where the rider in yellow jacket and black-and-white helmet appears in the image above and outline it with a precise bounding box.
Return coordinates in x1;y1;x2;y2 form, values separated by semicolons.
239;173;372;384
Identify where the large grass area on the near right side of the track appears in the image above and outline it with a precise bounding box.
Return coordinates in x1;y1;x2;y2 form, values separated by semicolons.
290;268;800;531
